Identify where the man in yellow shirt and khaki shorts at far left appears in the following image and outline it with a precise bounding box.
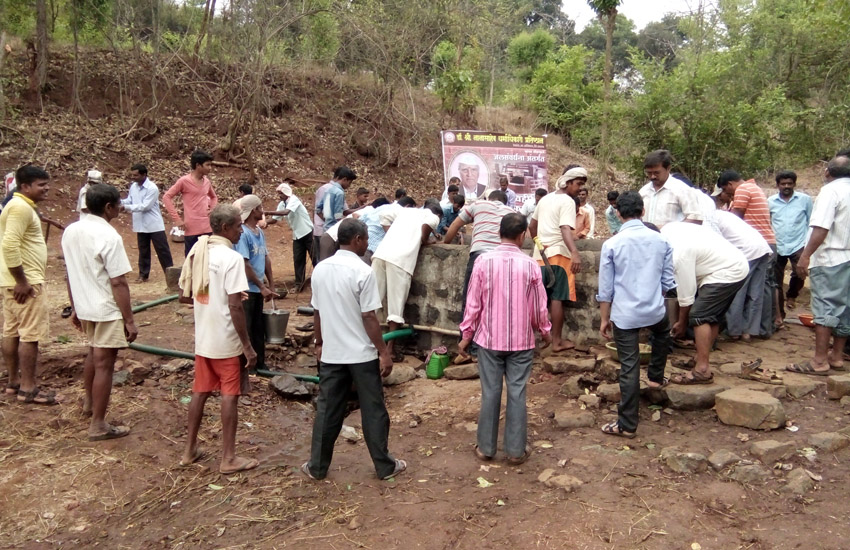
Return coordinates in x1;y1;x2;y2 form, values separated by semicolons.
0;166;56;405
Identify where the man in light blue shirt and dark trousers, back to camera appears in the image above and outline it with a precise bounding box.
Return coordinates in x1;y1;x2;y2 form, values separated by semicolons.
596;191;676;438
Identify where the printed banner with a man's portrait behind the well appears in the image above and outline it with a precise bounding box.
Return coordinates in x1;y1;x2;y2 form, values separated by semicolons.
440;130;549;209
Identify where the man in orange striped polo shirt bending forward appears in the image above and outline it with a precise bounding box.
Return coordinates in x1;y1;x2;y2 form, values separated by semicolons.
712;170;781;337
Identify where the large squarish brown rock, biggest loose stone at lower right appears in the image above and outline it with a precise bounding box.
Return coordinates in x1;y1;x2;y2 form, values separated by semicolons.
715;388;785;430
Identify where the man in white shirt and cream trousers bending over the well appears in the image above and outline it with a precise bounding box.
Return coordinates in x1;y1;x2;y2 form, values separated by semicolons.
372;204;443;358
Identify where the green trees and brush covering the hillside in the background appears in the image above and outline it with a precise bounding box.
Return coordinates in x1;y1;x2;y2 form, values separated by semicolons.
0;0;850;186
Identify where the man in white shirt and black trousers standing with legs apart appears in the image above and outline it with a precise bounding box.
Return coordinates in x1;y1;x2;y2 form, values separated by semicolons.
301;218;407;480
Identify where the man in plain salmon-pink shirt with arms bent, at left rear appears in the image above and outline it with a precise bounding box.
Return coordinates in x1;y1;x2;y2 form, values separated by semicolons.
162;151;218;256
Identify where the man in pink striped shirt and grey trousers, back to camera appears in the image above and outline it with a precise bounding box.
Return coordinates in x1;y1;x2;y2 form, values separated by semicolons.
458;213;552;466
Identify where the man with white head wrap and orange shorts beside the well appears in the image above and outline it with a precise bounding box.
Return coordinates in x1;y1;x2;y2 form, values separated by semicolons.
528;166;587;352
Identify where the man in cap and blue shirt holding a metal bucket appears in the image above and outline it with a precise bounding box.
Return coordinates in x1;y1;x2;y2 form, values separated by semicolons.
236;195;279;376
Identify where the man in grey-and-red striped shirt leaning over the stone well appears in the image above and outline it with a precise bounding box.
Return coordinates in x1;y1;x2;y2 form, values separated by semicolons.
443;190;513;309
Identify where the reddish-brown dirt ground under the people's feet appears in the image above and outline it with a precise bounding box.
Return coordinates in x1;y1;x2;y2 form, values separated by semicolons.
0;208;850;549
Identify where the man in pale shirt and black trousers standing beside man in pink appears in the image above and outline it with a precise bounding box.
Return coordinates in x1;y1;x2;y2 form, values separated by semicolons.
121;164;174;283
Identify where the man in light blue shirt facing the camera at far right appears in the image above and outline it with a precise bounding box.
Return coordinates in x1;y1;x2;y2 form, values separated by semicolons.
767;170;812;325
